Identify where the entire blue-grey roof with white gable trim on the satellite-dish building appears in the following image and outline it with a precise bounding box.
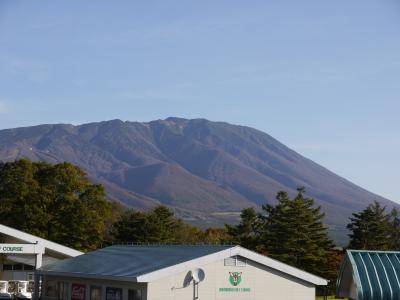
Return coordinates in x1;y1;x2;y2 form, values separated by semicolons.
38;245;328;285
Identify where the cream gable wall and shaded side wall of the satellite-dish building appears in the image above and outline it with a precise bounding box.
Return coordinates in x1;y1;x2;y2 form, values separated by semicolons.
42;260;315;300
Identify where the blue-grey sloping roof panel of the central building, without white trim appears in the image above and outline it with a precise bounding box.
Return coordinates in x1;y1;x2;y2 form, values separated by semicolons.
39;245;232;280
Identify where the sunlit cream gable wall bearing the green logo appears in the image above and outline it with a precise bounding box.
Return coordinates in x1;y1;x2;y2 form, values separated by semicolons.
147;260;315;300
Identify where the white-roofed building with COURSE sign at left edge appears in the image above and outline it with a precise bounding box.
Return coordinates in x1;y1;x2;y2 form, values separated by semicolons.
0;224;83;281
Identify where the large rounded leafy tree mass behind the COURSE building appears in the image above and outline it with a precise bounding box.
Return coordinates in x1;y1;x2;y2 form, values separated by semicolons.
0;159;111;250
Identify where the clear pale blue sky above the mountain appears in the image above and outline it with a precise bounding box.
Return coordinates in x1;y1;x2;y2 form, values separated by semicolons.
0;0;400;201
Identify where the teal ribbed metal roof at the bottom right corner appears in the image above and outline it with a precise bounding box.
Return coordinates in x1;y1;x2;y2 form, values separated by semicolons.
337;250;400;300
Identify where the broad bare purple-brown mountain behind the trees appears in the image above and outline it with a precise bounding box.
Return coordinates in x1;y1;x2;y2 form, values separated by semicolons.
0;118;396;244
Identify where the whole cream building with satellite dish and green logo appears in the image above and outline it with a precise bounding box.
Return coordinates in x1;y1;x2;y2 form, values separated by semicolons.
38;245;328;300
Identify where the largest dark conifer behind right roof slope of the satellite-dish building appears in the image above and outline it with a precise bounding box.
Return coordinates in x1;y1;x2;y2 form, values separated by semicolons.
263;188;334;276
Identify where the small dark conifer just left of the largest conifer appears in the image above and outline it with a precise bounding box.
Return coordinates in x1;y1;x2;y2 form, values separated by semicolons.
225;208;263;251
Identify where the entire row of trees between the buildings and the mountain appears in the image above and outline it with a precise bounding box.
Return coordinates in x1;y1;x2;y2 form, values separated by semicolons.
0;159;400;287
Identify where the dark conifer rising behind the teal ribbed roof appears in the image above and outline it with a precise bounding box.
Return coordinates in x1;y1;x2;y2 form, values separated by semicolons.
347;201;392;250
